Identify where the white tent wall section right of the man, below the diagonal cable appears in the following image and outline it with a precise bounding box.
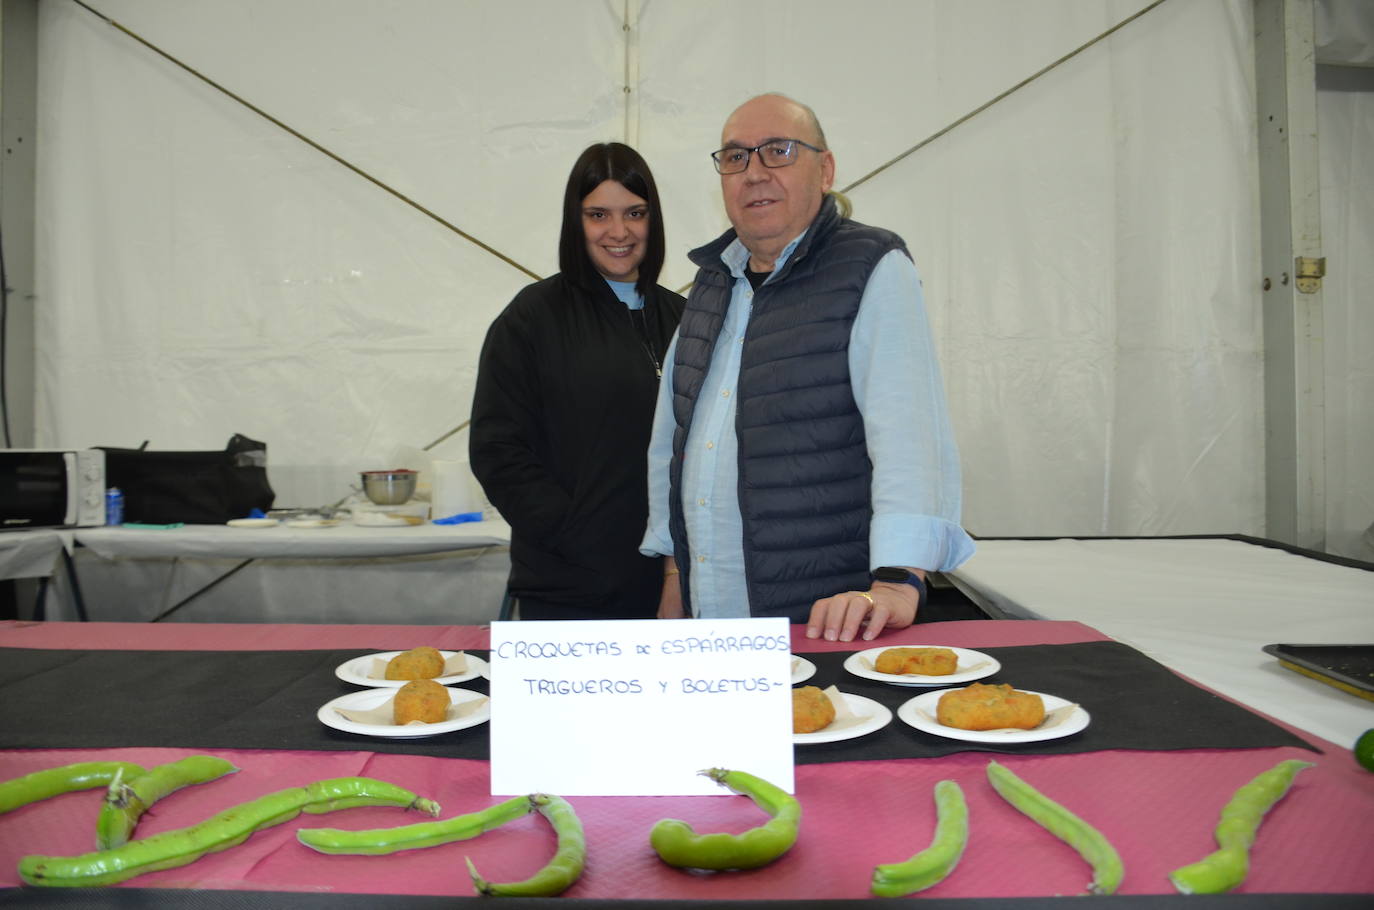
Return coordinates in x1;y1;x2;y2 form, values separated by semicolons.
855;3;1264;535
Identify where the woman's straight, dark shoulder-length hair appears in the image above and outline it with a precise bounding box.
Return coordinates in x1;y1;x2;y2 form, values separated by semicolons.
558;142;664;297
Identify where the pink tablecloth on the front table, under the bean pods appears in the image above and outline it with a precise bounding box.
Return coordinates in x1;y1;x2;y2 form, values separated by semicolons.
0;621;1374;900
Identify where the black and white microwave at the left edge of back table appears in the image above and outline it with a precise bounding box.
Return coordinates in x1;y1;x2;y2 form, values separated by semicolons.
0;448;104;531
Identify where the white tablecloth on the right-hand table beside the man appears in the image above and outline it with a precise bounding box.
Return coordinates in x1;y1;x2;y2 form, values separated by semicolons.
948;539;1374;745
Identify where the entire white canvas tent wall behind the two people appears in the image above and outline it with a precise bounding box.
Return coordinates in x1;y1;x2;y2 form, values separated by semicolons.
29;0;1369;563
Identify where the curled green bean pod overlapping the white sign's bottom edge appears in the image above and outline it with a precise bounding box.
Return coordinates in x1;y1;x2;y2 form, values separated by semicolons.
649;768;801;869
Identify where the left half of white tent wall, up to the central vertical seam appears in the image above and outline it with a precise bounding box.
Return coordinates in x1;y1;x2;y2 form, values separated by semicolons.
37;0;621;504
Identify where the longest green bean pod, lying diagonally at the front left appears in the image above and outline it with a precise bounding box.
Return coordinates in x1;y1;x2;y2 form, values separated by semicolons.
19;777;438;888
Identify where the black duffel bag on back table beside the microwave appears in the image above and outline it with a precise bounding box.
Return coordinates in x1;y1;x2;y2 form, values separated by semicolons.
100;433;276;525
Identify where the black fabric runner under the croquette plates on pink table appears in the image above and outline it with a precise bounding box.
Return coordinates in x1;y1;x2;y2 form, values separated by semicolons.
0;642;1314;764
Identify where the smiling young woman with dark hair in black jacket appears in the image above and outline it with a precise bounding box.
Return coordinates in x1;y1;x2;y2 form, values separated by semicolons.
470;142;683;619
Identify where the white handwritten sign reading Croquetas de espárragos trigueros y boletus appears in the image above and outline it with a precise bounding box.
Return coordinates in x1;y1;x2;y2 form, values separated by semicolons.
491;617;793;796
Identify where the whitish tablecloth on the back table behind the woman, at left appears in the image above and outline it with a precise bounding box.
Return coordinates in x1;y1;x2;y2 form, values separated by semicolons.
47;520;510;624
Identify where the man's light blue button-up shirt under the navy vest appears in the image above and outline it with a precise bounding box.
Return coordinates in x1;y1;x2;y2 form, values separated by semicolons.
640;234;974;619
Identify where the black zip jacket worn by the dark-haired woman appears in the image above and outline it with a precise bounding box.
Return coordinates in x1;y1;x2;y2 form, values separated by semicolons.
469;275;683;619
